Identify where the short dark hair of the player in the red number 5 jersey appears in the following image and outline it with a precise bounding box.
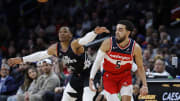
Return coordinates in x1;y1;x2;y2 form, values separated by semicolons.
118;20;135;31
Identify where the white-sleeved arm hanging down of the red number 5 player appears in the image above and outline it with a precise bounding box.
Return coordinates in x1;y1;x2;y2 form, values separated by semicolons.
89;39;111;91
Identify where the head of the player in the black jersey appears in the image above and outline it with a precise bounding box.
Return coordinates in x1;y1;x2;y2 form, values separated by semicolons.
58;26;72;42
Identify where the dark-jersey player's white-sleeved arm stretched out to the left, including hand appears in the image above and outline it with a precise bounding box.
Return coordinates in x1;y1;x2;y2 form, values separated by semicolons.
8;43;57;66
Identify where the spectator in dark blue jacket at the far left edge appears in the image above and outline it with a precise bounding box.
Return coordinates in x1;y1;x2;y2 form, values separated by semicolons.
0;64;16;101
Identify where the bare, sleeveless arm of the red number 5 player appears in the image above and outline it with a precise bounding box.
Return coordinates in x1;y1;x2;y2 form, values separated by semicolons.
134;43;148;95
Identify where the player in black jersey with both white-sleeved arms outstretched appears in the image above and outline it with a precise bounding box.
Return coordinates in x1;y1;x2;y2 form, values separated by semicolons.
8;27;110;101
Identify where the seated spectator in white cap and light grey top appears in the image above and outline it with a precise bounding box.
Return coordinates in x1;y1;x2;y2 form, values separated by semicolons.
17;59;60;101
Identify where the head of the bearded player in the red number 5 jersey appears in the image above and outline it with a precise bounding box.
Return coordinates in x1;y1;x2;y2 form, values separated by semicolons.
116;20;134;43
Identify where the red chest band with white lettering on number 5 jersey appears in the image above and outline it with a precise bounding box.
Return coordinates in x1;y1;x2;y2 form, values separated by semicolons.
107;52;132;61
